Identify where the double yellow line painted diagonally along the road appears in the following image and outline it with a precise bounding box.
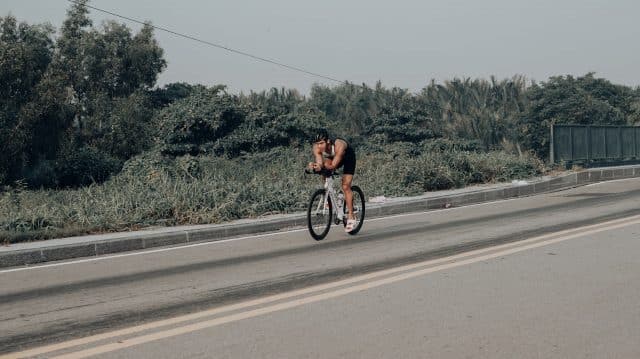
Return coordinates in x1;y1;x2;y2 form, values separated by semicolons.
5;215;640;359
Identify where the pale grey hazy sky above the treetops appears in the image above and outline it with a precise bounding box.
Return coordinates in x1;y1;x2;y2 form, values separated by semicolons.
0;0;640;93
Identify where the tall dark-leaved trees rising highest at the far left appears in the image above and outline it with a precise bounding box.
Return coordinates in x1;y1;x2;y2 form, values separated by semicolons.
0;0;166;188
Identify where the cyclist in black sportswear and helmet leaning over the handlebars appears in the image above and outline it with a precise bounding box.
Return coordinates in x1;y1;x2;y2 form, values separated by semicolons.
309;129;356;232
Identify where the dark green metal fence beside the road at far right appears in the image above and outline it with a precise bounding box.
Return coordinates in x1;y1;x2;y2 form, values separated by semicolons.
550;125;640;163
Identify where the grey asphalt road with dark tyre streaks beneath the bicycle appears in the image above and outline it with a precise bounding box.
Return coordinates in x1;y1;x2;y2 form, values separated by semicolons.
0;179;640;358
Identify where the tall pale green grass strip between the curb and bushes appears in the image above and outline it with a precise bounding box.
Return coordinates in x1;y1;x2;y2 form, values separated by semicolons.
0;146;542;243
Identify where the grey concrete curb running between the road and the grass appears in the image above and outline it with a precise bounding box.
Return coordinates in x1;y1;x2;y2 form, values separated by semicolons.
0;166;640;267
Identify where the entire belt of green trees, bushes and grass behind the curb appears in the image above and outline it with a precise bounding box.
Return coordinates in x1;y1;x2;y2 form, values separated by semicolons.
0;0;640;241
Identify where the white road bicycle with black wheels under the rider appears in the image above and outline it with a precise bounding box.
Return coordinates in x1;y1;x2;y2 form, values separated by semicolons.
305;169;365;241
